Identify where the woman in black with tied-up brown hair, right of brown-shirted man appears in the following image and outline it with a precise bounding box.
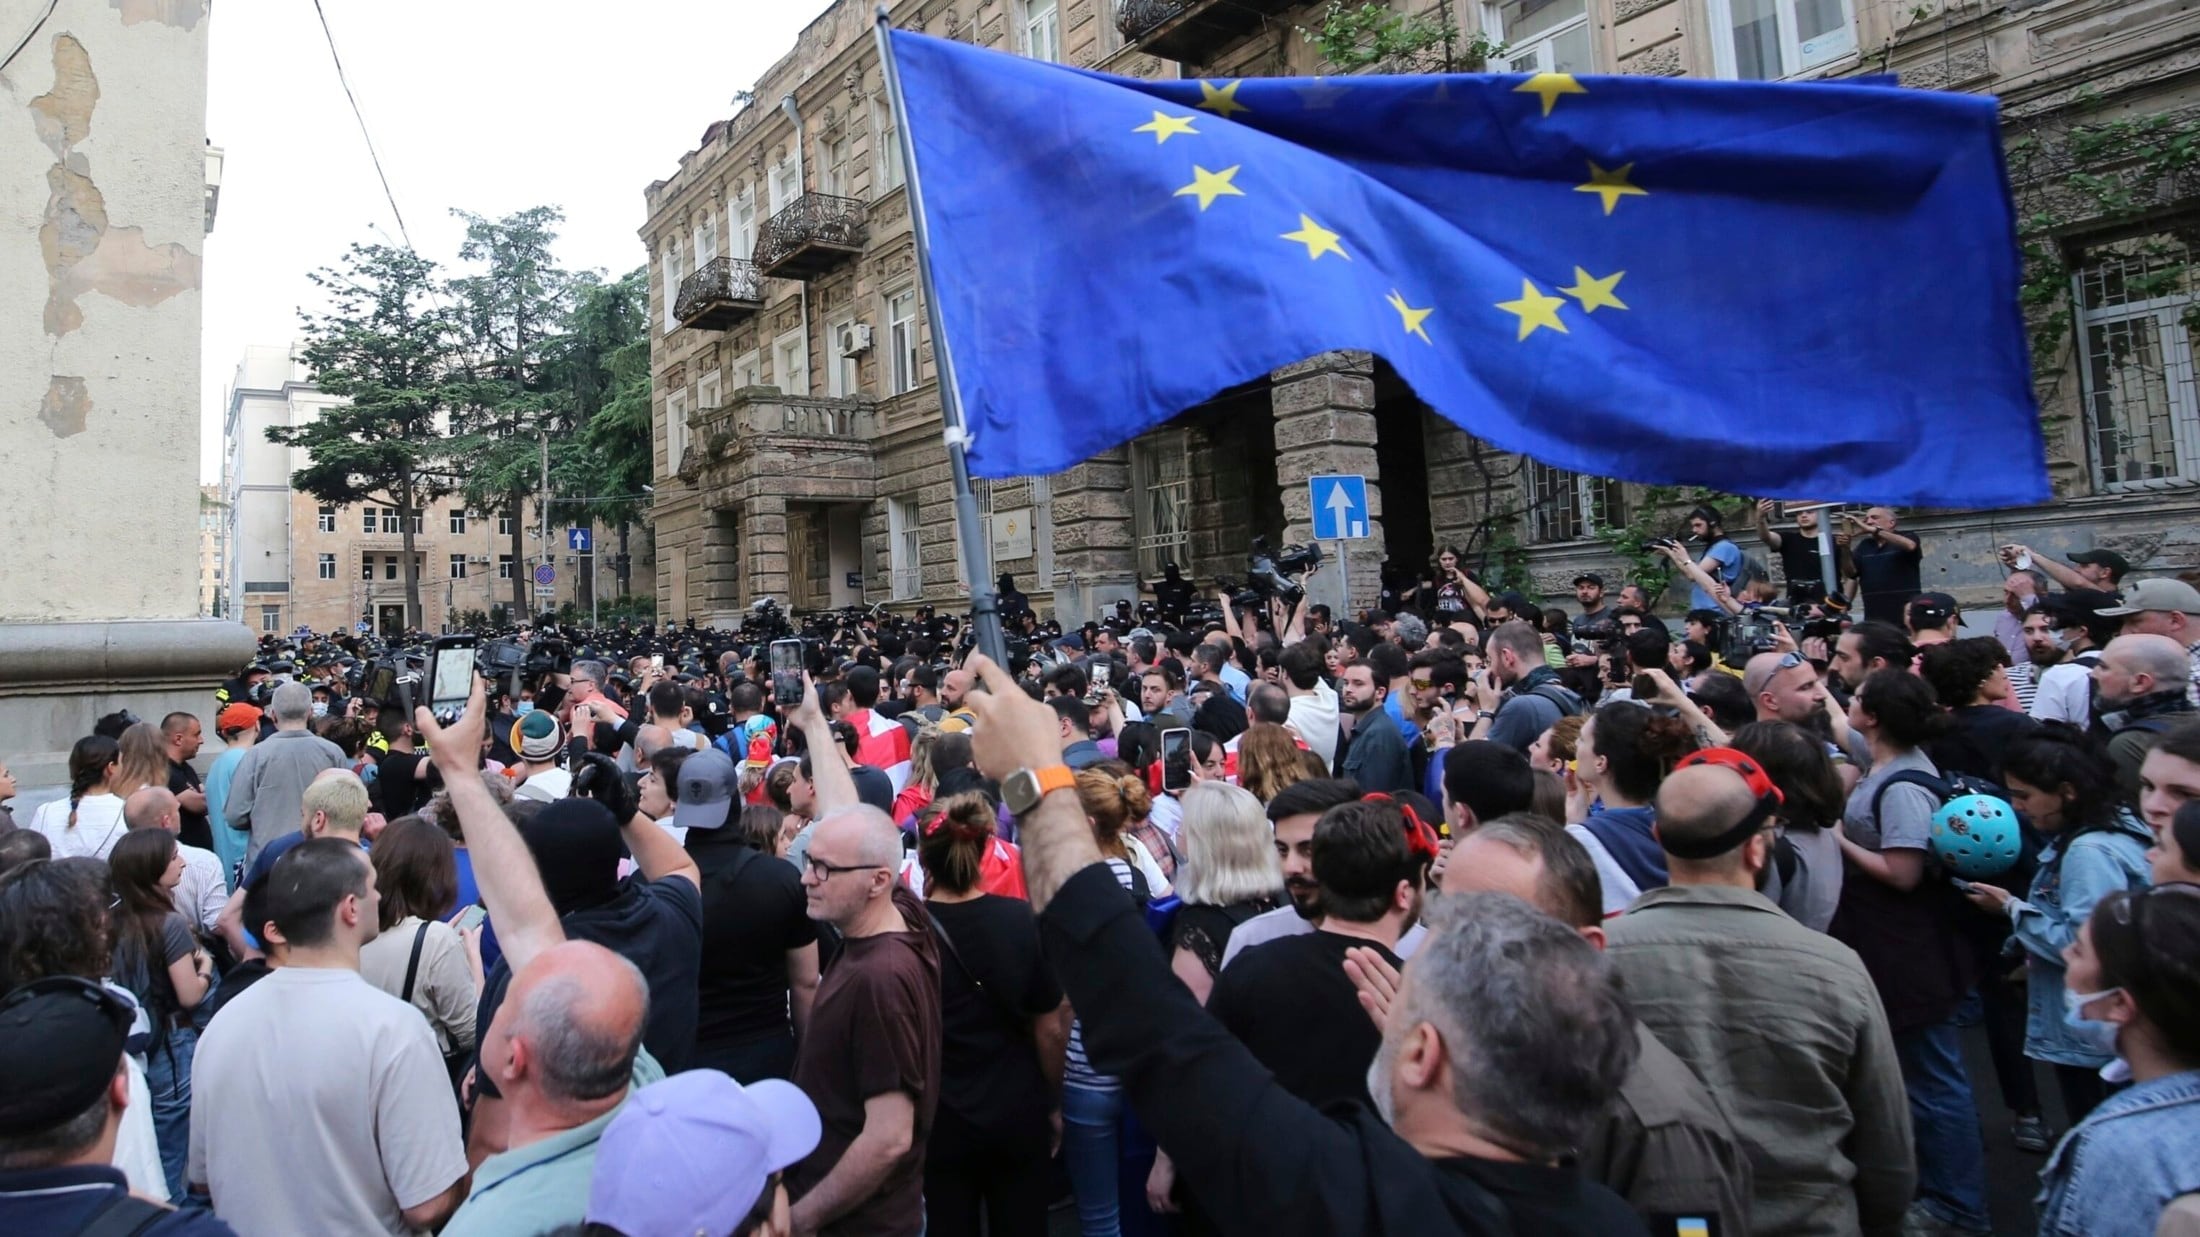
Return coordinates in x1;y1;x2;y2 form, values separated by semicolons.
917;792;1069;1237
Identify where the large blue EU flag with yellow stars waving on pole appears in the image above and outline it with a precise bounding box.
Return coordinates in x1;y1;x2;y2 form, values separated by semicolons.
891;31;2048;506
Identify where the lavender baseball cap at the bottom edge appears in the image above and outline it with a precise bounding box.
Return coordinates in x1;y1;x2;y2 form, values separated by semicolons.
587;1070;821;1237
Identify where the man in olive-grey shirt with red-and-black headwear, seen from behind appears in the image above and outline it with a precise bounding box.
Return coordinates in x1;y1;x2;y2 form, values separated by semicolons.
1601;748;1916;1237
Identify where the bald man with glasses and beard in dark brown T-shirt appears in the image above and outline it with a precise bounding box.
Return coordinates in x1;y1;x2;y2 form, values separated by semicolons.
788;805;942;1233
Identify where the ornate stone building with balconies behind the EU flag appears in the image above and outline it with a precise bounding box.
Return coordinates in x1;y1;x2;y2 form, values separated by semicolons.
642;0;2200;621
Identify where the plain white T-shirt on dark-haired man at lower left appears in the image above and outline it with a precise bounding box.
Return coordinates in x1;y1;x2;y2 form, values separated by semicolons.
189;966;466;1237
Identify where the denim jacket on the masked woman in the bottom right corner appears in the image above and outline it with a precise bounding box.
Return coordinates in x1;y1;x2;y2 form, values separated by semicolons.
2039;1070;2200;1237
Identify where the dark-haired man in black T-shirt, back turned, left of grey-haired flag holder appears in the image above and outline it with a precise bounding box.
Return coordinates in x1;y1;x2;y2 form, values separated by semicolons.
1208;799;1437;1107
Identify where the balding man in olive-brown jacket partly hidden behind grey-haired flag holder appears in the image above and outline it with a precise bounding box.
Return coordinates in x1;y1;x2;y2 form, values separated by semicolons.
1416;812;1751;1235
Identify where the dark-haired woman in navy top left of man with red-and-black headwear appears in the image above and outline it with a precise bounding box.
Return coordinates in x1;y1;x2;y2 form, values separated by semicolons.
1566;700;1701;916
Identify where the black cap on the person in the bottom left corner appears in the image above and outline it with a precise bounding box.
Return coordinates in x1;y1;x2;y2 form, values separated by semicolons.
0;975;132;1138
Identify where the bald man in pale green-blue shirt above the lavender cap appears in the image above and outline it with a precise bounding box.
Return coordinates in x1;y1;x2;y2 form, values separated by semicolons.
444;940;664;1237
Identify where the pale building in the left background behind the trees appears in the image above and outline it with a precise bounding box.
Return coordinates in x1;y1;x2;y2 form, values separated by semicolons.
220;346;656;634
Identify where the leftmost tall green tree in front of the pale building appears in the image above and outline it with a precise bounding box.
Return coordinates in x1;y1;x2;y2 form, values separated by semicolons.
268;244;460;625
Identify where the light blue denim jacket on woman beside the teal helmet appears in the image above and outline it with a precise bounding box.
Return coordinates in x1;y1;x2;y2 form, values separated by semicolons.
2009;812;2149;1070
